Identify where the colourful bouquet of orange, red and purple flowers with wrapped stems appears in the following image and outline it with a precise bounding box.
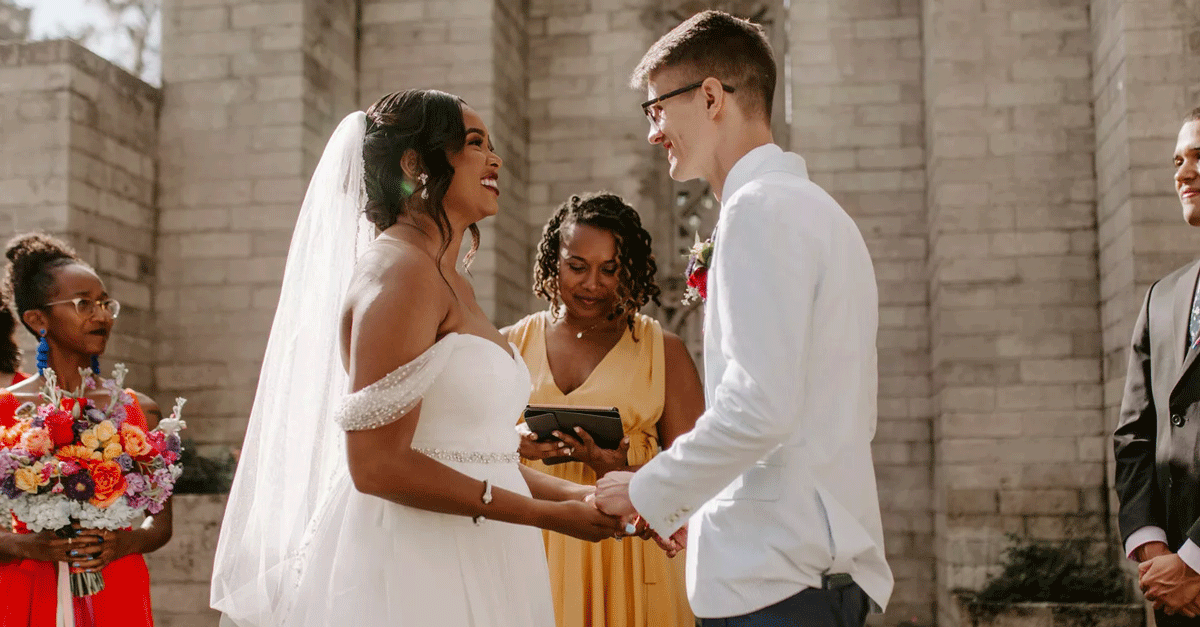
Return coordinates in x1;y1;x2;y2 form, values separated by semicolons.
0;364;186;597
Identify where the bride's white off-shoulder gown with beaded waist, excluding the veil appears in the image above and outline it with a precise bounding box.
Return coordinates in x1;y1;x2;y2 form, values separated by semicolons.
276;334;554;627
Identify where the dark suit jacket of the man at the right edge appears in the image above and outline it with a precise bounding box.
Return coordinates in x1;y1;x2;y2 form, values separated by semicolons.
1114;259;1200;551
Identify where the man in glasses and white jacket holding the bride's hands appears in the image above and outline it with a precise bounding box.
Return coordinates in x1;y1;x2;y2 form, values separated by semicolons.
596;11;893;627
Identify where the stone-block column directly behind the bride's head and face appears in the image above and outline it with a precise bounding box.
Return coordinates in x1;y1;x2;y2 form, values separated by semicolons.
359;0;529;326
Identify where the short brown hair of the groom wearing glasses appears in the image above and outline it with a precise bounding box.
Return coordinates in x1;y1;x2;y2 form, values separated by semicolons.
629;11;775;120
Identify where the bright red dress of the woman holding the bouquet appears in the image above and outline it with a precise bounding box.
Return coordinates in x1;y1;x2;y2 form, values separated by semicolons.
0;392;154;627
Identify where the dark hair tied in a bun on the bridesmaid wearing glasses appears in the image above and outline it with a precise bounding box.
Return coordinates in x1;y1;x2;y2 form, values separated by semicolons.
4;233;90;336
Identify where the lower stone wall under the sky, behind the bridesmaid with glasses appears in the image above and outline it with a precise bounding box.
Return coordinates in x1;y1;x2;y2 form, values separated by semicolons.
0;41;160;384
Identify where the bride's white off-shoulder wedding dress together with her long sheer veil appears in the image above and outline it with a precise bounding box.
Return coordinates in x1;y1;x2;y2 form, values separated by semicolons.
210;112;554;627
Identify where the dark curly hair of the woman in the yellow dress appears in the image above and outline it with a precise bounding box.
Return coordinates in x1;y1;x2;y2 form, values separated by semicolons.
533;192;662;329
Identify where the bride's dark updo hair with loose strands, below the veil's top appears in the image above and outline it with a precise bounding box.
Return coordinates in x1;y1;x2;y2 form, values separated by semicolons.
362;89;479;264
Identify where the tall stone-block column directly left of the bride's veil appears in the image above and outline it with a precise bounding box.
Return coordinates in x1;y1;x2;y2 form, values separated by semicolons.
156;0;358;447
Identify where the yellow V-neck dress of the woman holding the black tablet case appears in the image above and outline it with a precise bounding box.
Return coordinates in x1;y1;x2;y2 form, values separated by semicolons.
509;311;695;627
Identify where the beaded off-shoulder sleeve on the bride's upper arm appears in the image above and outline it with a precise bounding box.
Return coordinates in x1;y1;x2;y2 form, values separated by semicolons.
334;338;451;431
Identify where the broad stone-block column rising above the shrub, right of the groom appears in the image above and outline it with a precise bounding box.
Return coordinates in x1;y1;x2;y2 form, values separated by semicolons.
923;0;1110;626
